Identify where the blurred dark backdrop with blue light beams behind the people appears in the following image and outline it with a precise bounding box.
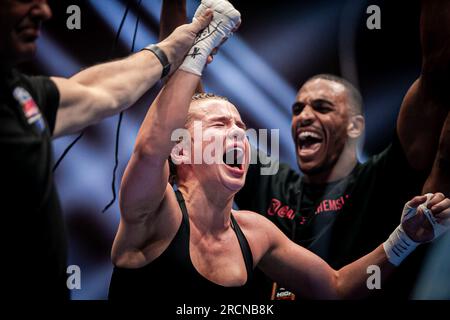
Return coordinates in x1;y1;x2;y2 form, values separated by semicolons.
17;0;450;299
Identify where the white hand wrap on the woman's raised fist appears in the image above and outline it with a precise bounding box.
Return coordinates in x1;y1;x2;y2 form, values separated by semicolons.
180;0;241;76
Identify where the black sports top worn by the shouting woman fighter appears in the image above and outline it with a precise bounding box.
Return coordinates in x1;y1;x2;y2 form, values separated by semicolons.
109;190;253;302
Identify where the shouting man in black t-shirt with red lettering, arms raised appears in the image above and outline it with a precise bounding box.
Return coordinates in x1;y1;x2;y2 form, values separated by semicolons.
235;1;450;298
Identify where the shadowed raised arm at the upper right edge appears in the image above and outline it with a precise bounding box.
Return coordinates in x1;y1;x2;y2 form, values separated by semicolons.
397;0;450;173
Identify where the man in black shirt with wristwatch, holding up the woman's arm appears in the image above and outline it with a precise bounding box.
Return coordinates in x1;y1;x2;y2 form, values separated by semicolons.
0;0;211;299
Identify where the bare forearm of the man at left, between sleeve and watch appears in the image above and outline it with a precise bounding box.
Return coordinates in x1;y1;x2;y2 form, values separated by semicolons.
52;51;166;137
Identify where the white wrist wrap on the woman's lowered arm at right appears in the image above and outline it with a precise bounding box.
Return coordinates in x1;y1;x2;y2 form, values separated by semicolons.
383;225;420;266
